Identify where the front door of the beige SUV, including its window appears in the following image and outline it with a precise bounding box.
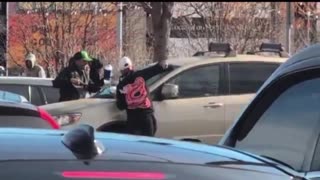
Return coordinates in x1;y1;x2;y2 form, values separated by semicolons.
154;64;225;143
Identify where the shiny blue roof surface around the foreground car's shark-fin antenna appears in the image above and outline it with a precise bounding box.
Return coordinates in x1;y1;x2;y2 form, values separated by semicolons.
0;128;302;179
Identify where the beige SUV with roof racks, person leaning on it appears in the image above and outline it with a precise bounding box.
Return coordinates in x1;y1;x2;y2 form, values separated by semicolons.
42;43;287;143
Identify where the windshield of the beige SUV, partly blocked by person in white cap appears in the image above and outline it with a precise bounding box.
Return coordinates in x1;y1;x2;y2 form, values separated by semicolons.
92;66;177;99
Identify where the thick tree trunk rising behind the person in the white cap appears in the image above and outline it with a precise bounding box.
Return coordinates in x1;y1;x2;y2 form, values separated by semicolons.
151;2;174;62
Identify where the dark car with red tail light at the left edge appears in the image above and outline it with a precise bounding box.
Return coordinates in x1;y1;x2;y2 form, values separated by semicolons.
0;100;60;129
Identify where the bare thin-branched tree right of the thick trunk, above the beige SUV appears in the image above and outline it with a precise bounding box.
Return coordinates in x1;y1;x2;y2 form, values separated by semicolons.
169;2;283;55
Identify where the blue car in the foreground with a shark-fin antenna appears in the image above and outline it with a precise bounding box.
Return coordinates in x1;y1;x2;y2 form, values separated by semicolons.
0;126;304;180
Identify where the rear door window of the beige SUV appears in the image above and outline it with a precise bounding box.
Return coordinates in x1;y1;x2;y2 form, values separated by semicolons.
229;63;280;94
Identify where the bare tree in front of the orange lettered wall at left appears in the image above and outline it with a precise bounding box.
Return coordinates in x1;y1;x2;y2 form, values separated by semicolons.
10;2;116;76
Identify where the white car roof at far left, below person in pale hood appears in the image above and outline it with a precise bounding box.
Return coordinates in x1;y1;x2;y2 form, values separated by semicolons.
0;76;53;86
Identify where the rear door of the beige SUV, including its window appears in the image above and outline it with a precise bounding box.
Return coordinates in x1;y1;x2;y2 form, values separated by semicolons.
225;62;280;130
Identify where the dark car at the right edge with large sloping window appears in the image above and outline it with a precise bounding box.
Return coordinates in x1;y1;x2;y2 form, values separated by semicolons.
219;44;320;179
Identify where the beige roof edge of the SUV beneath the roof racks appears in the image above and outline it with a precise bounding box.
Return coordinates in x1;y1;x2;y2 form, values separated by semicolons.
167;54;288;66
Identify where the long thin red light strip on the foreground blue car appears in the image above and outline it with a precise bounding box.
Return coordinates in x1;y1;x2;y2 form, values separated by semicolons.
62;171;166;180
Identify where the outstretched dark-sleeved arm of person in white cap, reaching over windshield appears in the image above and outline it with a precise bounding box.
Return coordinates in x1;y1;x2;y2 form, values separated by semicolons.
136;61;169;81
